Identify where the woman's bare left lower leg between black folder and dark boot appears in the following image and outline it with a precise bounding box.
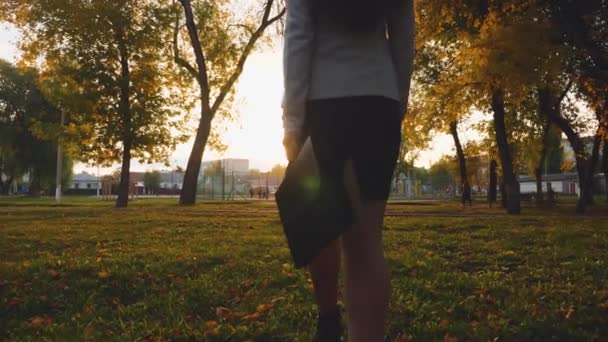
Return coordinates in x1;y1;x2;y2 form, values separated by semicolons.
309;240;340;315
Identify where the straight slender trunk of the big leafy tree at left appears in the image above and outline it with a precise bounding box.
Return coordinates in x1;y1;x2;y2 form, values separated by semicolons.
116;28;133;208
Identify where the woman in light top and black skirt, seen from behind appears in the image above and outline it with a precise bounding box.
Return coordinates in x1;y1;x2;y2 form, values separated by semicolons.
283;0;414;342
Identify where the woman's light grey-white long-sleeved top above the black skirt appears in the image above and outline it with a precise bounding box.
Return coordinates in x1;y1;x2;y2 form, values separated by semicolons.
283;0;415;131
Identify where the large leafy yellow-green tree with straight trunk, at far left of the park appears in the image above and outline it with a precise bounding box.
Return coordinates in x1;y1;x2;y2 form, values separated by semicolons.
3;0;188;207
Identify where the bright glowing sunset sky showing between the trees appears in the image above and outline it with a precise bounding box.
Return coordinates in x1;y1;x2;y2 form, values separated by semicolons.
0;24;476;174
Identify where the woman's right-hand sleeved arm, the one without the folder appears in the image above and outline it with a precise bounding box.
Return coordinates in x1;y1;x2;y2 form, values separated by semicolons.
387;0;416;113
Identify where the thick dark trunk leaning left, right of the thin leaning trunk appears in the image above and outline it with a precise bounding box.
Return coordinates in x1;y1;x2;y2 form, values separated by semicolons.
492;89;521;215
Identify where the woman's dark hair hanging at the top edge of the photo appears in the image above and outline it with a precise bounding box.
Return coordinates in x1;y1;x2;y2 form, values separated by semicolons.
311;0;402;31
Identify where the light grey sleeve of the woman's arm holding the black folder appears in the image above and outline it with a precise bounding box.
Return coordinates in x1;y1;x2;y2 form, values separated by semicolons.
283;0;314;135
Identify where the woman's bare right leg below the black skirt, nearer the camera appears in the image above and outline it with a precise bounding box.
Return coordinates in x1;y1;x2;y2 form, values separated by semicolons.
342;201;390;342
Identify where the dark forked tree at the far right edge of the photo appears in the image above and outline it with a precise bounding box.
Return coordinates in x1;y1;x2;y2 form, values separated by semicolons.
540;0;608;213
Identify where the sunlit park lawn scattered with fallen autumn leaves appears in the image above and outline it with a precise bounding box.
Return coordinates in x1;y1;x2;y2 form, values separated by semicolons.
0;198;608;341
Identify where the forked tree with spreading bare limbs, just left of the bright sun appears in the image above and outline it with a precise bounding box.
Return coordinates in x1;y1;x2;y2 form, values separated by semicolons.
173;0;285;205
